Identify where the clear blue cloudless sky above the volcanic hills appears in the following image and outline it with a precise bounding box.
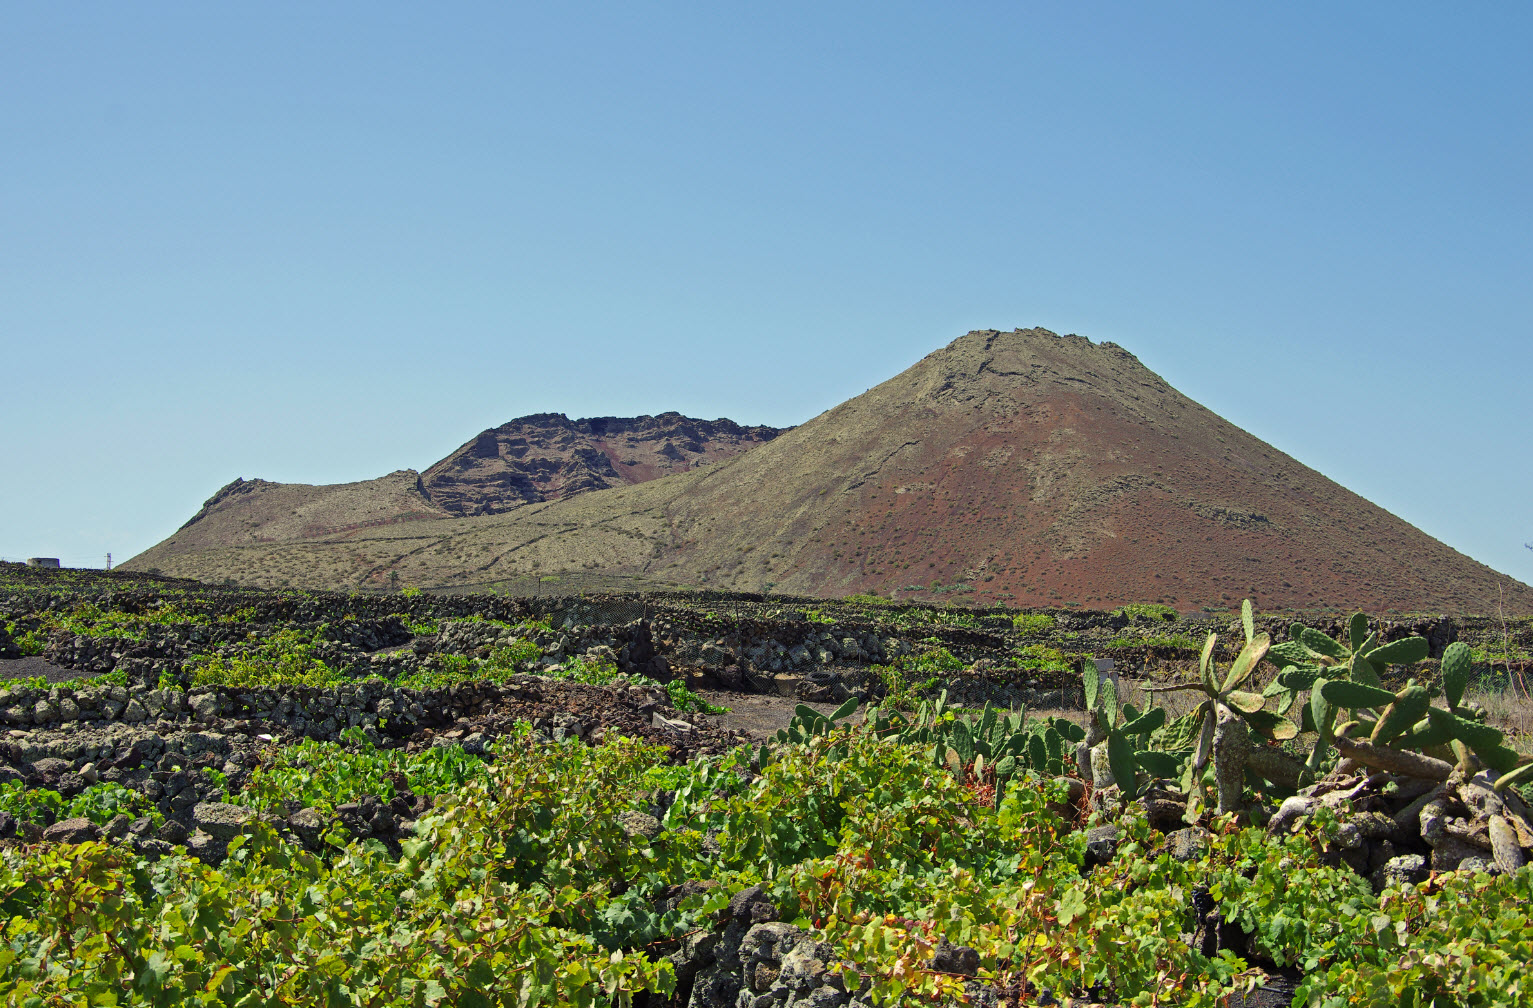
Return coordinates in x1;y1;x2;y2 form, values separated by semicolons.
0;7;1533;582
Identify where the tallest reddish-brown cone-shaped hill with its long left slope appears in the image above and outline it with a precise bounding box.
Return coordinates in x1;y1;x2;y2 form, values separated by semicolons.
135;329;1533;613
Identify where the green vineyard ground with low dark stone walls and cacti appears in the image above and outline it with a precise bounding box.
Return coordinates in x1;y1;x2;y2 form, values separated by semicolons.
0;565;1533;1008
